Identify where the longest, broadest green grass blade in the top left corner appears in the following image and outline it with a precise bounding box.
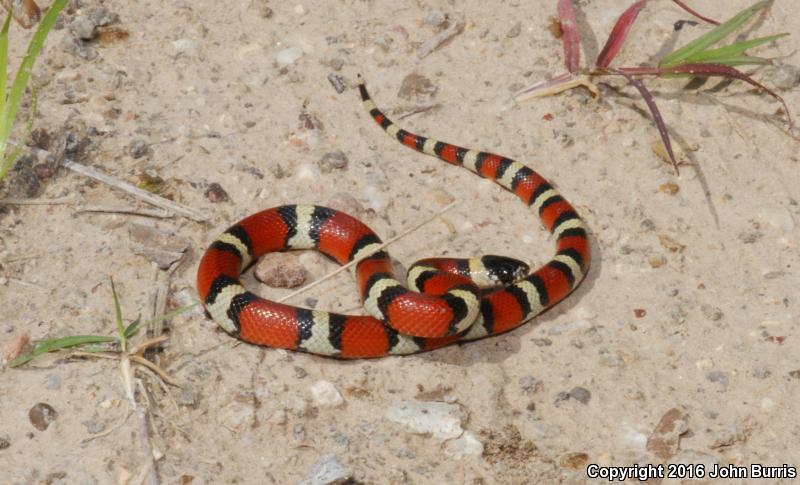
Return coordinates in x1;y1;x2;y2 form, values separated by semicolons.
0;0;69;159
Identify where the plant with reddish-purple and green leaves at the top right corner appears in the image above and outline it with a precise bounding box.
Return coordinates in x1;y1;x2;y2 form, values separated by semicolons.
515;0;794;172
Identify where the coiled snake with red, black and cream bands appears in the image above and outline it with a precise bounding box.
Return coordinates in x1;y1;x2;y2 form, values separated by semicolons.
197;76;590;359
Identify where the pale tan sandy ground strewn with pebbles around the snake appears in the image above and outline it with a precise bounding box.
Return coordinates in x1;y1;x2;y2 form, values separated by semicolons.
0;0;800;484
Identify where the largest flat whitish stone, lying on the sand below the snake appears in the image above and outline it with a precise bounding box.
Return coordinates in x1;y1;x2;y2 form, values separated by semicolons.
384;401;464;441
